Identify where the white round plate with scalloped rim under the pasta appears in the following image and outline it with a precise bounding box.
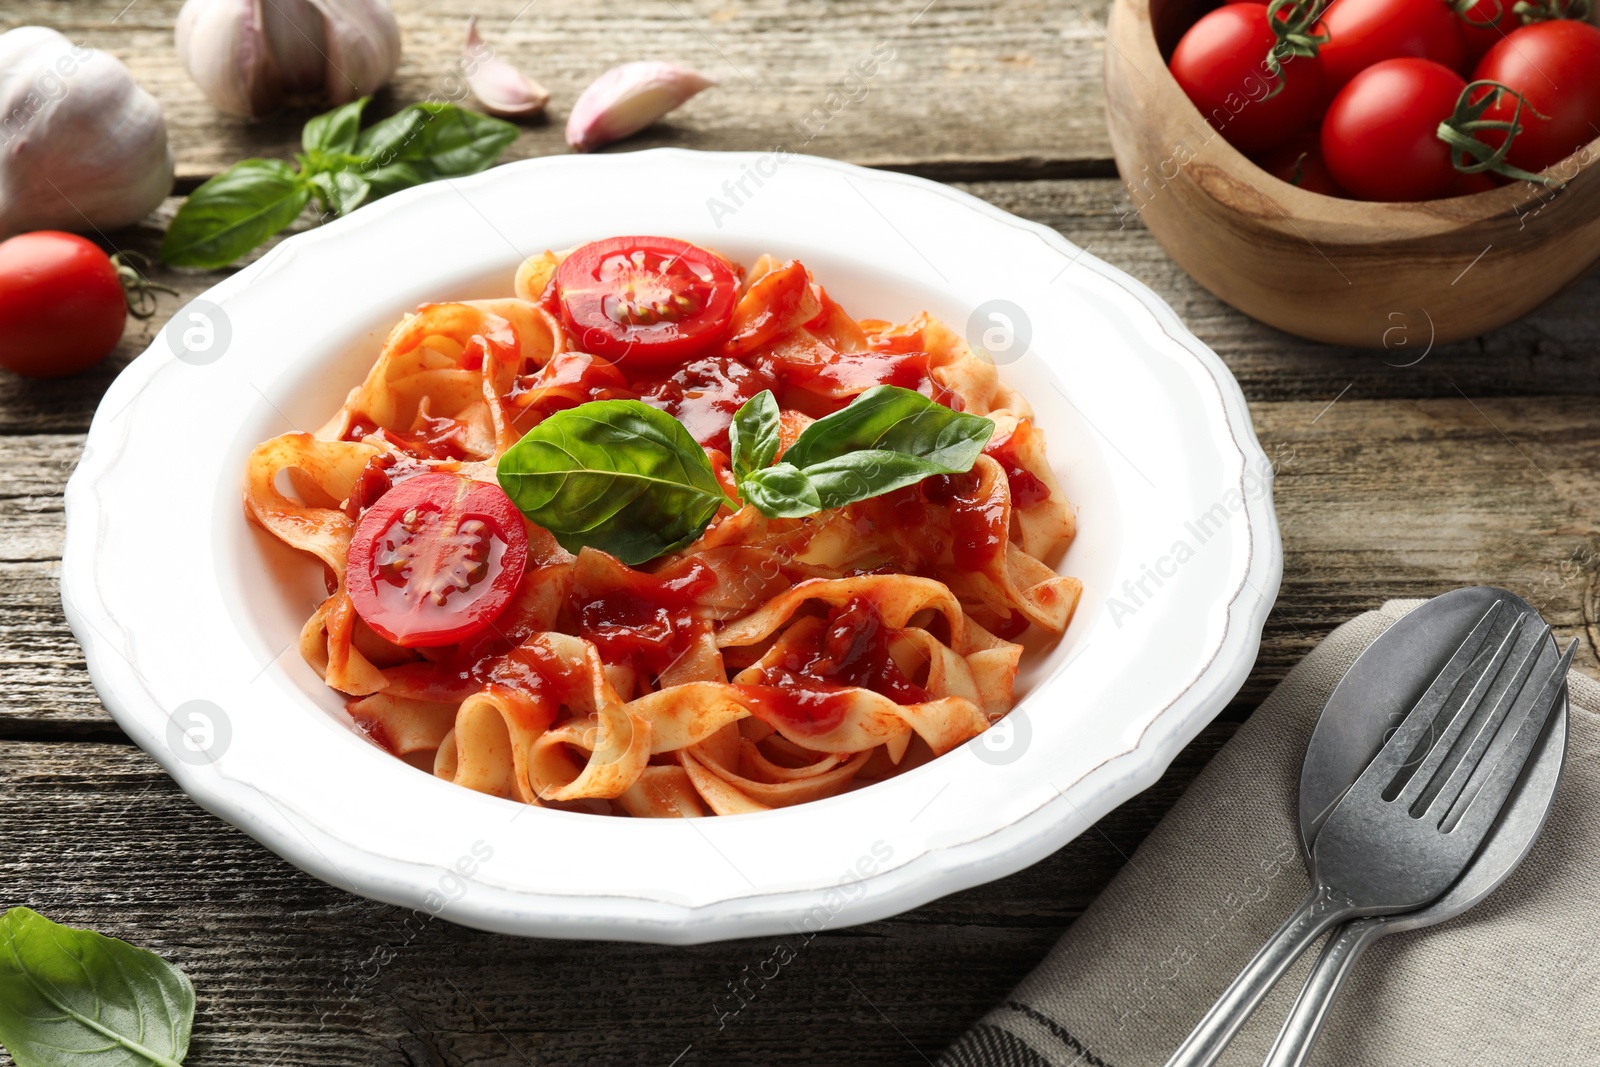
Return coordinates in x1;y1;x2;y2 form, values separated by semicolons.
61;150;1283;944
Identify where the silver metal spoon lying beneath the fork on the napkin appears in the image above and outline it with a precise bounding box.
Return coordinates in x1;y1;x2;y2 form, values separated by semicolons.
1267;585;1566;1067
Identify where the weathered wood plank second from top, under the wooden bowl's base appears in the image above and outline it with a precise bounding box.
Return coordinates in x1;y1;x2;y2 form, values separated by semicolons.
0;179;1600;434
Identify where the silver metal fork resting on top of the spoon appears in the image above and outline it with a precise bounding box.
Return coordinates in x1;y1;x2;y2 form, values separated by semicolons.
1166;601;1570;1067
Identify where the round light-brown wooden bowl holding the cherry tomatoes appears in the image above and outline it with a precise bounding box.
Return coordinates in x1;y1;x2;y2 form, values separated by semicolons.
1106;0;1600;349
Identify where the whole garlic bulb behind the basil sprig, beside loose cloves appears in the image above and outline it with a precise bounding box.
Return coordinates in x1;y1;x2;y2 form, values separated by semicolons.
178;0;400;118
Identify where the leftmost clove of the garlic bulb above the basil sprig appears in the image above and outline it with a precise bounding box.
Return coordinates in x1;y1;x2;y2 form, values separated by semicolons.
178;0;283;118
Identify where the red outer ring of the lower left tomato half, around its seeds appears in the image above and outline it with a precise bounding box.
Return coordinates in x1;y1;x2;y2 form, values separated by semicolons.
346;472;528;648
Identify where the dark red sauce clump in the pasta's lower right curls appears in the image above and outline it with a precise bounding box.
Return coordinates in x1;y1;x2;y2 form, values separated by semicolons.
739;597;933;734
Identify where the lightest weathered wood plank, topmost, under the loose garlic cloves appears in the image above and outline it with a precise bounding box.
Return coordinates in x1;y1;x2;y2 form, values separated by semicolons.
0;0;1110;186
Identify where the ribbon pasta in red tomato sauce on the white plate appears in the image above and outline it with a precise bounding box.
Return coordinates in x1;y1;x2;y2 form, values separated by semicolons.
245;238;1082;817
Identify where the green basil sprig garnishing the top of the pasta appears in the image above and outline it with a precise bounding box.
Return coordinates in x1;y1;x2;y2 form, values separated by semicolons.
498;386;995;565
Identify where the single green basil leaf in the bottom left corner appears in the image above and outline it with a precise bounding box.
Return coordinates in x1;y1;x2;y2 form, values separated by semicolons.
0;907;195;1067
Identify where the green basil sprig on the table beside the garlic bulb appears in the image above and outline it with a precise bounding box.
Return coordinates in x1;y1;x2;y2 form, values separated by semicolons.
162;96;517;267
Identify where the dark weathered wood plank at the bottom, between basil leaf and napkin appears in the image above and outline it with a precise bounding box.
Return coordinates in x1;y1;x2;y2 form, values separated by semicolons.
0;735;1232;1067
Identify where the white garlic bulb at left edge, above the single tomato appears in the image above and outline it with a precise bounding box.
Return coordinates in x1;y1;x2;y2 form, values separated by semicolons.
0;26;173;237
